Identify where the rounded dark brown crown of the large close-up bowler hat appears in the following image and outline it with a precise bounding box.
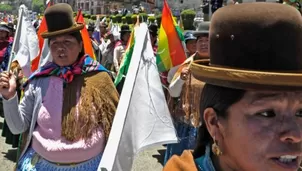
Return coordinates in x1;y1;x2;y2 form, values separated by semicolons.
210;3;302;71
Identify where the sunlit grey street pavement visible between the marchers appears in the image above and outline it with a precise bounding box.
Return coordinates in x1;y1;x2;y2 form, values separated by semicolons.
0;118;165;171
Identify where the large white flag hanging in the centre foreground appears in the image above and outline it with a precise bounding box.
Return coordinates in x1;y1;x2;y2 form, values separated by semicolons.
98;23;177;171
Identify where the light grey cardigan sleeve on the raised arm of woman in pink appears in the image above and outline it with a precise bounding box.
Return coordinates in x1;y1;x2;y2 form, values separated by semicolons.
3;84;35;135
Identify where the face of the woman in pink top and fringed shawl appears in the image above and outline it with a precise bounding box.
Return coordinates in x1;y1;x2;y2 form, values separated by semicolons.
49;35;82;66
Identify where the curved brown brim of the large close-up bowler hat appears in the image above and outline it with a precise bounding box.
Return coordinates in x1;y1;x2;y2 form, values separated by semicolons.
191;59;302;90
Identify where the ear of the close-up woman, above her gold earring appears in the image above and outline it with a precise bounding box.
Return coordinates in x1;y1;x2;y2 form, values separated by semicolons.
203;108;222;141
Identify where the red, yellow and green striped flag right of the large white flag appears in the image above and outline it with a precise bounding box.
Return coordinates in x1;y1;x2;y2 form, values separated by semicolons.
156;0;186;72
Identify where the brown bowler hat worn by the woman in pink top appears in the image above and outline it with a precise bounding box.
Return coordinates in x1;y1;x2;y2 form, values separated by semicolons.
41;3;84;38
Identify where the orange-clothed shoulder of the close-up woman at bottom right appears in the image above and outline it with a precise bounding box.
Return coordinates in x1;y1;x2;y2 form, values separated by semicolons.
163;150;197;171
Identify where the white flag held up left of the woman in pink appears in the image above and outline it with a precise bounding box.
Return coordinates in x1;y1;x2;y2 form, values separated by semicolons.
14;5;39;77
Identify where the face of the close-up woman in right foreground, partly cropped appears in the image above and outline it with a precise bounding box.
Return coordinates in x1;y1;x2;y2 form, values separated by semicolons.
212;91;302;171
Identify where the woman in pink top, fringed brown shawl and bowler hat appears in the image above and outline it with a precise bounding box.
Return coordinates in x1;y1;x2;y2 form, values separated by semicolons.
0;3;118;171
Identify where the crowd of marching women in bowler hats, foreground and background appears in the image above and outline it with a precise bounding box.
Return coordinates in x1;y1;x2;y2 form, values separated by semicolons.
0;0;302;171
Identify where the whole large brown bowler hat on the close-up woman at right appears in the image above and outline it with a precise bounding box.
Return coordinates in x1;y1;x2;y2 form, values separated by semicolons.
191;2;302;90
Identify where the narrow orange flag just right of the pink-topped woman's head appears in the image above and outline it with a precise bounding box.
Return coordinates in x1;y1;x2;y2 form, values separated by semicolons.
76;9;96;59
